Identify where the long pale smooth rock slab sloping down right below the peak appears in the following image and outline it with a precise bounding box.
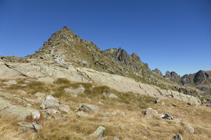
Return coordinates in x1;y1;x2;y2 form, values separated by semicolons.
0;63;200;105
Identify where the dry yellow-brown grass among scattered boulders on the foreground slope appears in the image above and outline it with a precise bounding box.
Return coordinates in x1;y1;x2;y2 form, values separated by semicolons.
0;78;211;140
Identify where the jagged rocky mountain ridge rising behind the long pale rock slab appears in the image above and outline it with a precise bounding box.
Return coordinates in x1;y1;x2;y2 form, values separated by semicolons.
1;26;211;105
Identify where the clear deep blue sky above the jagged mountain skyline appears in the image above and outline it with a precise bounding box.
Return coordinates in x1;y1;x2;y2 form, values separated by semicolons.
0;0;211;76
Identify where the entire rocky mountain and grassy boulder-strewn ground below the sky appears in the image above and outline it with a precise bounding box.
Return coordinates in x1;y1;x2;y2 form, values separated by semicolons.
0;27;211;140
